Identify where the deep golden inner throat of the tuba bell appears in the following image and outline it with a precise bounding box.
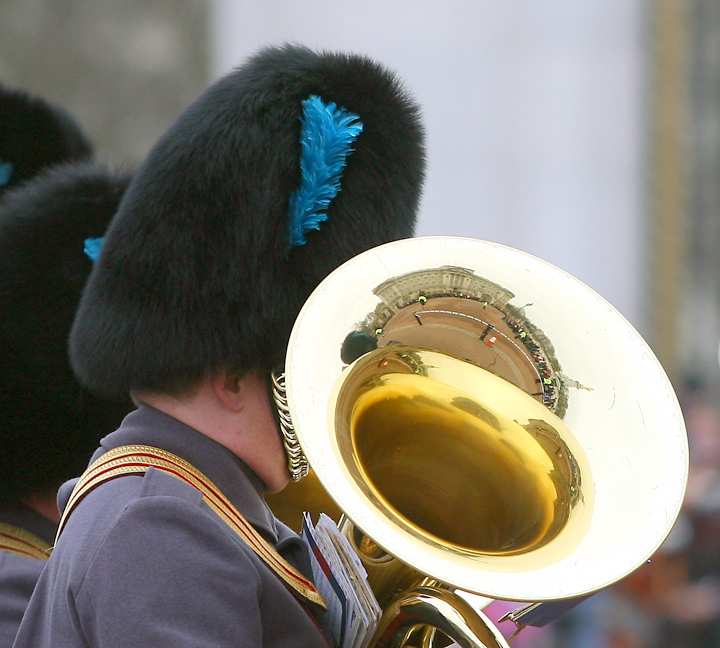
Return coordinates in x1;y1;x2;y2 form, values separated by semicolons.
335;345;592;555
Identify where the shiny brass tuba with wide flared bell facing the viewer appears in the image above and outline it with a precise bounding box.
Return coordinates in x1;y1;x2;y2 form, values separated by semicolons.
270;237;688;646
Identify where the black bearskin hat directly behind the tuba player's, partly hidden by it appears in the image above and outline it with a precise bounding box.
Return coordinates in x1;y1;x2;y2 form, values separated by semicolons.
0;163;131;501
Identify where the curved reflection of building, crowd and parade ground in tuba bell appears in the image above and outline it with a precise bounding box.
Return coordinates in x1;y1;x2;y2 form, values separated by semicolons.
362;266;567;419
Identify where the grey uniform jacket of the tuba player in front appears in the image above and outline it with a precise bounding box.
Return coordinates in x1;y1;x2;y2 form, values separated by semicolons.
15;406;327;648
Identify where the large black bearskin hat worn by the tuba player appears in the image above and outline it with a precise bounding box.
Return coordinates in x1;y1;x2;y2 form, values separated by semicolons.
70;45;425;396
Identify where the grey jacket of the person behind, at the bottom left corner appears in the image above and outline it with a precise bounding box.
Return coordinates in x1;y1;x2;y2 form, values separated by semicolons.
0;504;57;648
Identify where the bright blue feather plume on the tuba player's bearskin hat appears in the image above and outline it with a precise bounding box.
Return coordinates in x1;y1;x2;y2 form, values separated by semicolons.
290;95;363;248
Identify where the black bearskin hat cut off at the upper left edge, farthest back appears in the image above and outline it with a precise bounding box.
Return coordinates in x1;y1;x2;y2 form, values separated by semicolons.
0;86;92;195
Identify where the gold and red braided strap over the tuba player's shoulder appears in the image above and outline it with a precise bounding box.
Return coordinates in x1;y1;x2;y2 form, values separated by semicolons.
56;445;325;608
